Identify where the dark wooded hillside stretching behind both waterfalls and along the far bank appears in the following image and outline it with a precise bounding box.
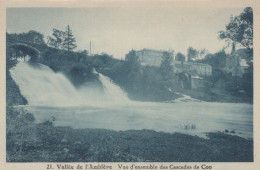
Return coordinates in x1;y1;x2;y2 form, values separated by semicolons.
6;31;253;104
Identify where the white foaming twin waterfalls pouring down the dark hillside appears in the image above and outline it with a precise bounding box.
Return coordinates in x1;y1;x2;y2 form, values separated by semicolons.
10;62;128;106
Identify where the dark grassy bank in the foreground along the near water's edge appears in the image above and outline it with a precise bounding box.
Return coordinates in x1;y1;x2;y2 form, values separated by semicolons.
7;108;253;162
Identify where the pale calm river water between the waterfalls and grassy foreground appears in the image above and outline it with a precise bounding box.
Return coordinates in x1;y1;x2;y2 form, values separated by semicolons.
21;102;253;138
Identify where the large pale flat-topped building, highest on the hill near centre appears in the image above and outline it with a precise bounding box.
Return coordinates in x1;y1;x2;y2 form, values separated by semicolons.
136;48;173;67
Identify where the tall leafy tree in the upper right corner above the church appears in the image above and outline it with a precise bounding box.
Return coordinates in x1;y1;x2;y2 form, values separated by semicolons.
219;7;253;60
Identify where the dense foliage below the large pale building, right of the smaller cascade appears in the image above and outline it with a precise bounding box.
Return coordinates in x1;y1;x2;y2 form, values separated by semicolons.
94;51;178;101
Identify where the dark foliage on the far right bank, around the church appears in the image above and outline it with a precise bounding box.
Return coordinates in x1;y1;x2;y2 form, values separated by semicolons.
196;49;253;99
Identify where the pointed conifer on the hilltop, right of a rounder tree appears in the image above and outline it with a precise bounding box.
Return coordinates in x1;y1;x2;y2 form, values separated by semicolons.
62;25;77;51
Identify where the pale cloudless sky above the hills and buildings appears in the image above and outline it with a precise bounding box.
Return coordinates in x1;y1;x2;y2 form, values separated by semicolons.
6;7;243;59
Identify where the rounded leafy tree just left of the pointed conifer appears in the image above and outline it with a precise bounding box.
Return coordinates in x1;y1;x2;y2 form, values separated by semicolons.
47;28;65;49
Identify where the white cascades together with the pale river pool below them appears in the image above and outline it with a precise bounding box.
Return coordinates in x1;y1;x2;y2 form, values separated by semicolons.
11;63;253;138
